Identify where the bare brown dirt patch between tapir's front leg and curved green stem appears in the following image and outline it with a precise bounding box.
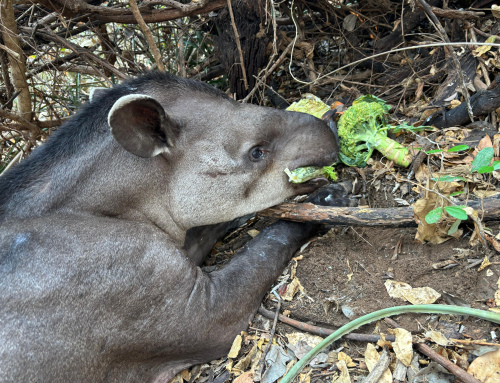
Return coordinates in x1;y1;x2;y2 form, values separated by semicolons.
276;227;500;339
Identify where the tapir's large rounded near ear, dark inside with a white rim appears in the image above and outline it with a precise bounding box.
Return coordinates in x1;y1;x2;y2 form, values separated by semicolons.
108;94;175;158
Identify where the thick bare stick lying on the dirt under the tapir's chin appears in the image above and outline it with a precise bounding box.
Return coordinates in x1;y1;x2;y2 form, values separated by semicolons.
258;197;500;227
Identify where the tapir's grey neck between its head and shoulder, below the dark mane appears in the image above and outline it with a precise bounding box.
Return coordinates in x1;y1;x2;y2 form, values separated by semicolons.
0;137;187;247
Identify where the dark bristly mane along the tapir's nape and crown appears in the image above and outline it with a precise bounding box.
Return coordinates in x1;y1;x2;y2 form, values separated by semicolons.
0;72;229;220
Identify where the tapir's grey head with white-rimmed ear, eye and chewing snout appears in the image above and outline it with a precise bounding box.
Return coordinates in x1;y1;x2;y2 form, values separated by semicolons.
108;74;338;229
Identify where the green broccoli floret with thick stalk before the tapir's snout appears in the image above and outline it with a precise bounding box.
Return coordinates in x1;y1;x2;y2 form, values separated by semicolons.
337;95;411;167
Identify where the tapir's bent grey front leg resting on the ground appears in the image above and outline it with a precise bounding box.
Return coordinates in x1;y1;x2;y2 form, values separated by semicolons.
161;185;356;380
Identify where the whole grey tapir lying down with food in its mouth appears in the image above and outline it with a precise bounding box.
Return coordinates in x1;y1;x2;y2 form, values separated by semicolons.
0;73;337;383
